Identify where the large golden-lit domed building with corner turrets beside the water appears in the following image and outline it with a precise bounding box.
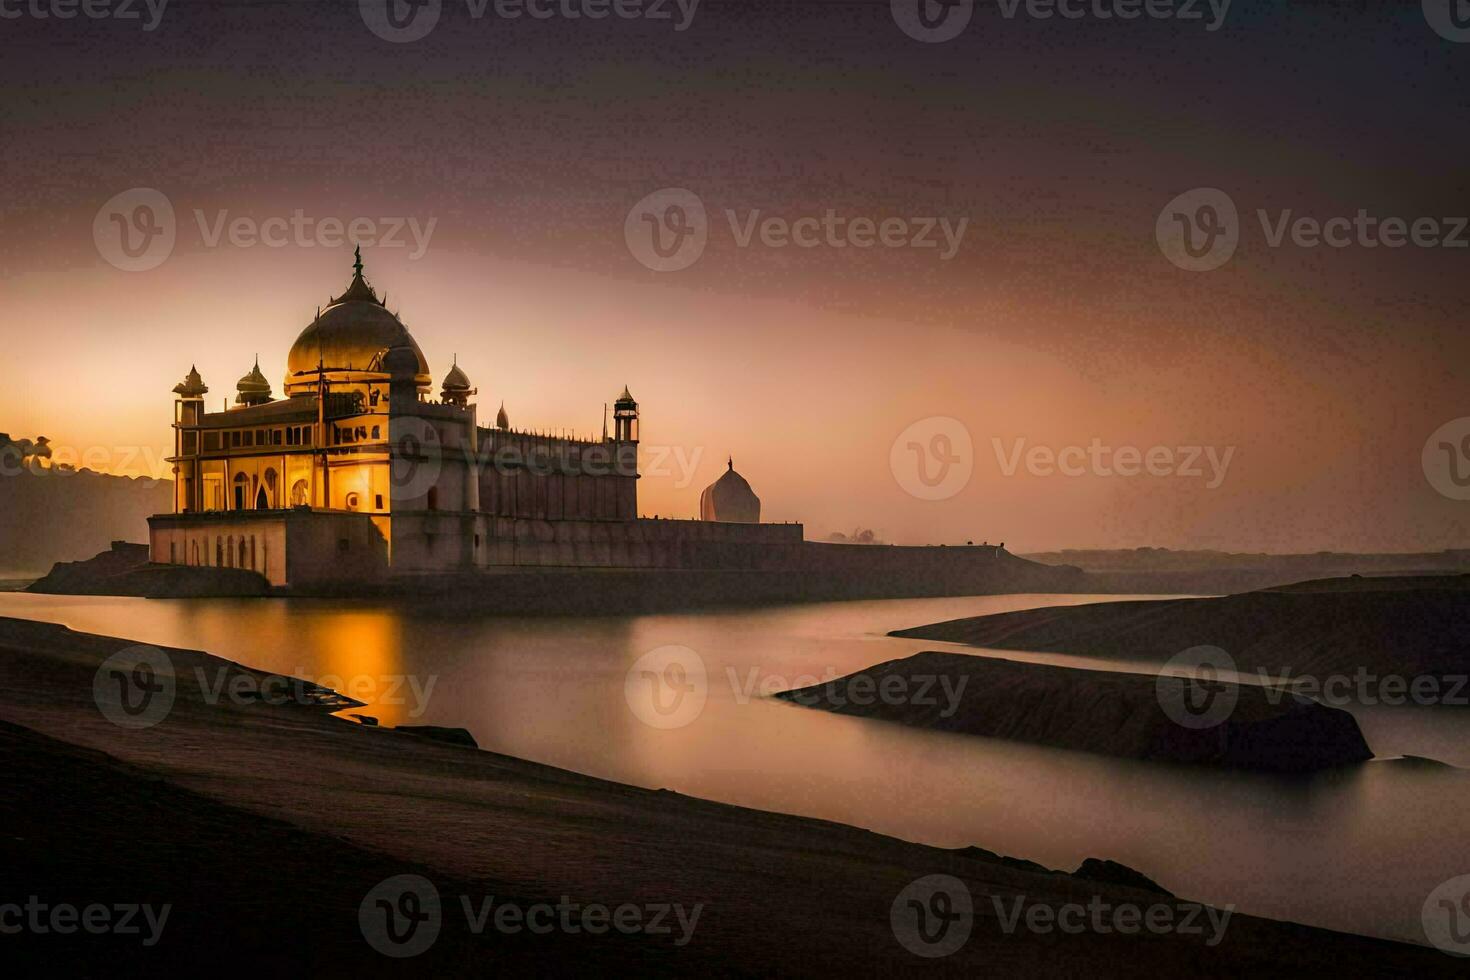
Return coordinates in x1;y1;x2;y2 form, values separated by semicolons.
148;250;649;585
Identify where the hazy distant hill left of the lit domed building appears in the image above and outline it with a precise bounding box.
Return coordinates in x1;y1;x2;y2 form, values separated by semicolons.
0;464;173;577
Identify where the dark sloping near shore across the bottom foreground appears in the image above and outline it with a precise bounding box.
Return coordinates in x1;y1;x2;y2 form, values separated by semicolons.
0;620;1455;976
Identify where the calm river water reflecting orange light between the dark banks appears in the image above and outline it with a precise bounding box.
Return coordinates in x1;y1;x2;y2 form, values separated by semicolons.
0;594;1470;942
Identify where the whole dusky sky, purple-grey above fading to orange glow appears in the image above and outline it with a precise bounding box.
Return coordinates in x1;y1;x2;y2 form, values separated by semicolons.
0;0;1470;551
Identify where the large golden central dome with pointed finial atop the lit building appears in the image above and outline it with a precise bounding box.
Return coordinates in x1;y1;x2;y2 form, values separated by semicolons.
285;257;434;392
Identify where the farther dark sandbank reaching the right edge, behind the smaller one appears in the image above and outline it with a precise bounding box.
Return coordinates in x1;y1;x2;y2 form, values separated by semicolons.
892;576;1470;681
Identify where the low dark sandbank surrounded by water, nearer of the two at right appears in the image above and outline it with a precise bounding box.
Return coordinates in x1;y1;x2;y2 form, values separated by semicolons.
776;652;1373;773
